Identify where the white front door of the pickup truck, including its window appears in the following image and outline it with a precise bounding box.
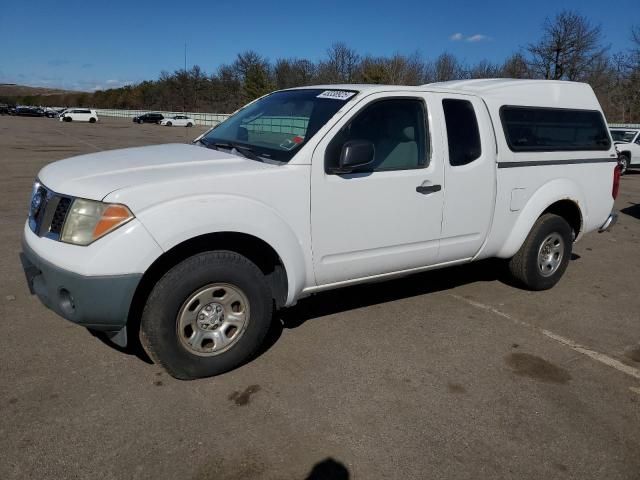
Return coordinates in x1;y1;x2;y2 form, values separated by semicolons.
311;92;444;285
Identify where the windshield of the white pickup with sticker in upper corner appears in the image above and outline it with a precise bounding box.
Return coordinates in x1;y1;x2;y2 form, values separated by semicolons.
200;89;357;162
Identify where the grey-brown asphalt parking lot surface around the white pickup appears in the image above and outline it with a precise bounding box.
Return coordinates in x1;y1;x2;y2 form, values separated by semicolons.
0;116;640;480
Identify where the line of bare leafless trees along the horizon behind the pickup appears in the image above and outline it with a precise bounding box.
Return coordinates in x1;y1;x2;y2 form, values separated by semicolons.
7;10;640;123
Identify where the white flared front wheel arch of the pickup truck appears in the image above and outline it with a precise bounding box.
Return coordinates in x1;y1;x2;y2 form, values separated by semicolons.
137;194;308;305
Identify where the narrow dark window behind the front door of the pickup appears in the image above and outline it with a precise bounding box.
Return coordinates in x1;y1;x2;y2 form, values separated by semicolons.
442;98;482;167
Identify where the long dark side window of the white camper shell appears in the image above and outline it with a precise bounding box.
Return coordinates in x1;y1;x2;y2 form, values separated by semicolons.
500;106;611;152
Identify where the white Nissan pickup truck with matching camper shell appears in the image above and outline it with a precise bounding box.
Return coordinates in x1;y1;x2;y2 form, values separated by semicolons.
21;80;619;379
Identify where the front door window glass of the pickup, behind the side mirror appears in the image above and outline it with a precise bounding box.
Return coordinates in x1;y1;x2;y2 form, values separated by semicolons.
325;98;429;173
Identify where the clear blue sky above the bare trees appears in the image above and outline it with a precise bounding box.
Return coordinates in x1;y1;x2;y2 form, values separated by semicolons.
0;0;640;91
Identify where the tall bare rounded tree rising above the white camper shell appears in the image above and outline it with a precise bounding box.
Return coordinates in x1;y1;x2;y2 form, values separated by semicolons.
527;10;607;80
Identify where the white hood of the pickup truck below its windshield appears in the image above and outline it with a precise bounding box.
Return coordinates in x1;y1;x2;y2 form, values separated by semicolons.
38;143;277;200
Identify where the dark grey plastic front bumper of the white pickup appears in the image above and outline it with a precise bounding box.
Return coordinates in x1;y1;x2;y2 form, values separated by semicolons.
20;241;142;344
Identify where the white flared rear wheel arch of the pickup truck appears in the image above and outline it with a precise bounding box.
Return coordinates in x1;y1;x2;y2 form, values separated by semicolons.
497;178;587;258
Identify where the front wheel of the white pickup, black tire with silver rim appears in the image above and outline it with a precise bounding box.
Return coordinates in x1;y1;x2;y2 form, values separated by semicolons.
140;250;273;380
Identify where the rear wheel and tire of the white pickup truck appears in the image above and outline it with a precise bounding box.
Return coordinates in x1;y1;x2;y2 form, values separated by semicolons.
509;213;573;290
